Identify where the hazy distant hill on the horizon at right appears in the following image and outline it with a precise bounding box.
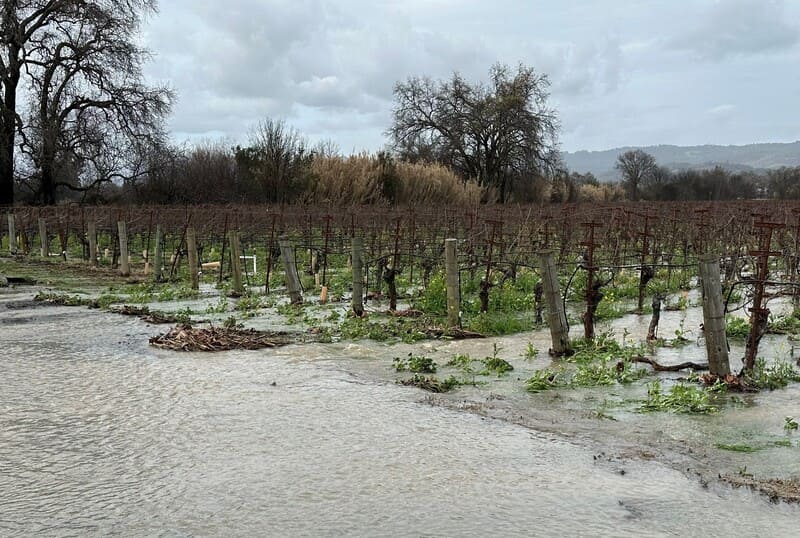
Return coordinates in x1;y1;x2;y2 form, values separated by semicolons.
562;141;800;181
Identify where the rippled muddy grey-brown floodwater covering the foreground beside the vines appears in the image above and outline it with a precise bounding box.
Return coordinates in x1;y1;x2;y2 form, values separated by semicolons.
0;288;800;537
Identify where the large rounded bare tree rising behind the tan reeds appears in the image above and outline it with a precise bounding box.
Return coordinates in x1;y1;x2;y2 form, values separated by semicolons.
389;64;559;202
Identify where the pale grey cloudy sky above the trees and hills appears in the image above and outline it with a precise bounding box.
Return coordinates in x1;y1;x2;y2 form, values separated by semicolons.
143;0;800;153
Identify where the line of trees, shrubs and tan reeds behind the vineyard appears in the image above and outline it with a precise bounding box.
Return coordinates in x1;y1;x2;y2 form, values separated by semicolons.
0;0;800;206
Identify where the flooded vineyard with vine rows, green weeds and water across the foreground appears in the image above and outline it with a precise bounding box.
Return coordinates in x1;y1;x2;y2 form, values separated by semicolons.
0;203;800;536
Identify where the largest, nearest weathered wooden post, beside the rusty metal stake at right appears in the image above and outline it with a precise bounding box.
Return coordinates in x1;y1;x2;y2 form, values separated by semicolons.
700;254;731;377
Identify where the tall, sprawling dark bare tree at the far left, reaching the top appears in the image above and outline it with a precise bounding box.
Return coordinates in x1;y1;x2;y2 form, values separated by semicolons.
0;0;172;204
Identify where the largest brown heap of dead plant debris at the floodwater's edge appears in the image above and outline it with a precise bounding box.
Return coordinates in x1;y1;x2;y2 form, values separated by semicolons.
150;325;291;351
